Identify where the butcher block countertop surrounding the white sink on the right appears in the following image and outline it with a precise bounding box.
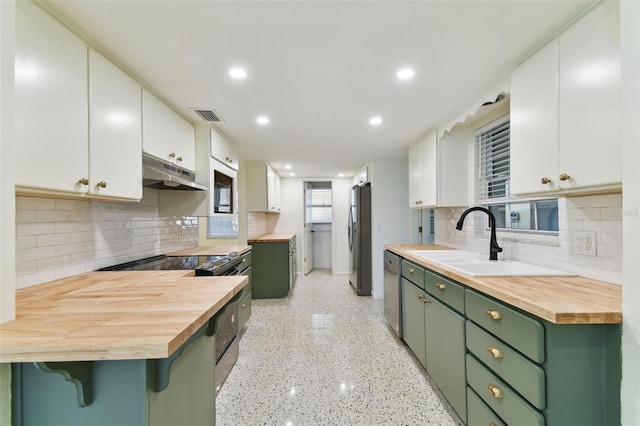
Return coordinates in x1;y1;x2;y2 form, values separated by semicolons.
385;245;622;324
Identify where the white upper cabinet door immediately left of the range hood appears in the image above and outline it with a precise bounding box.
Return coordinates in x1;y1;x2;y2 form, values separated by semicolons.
89;49;142;200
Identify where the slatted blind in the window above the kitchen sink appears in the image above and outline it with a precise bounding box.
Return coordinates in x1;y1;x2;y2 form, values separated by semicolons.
476;116;511;202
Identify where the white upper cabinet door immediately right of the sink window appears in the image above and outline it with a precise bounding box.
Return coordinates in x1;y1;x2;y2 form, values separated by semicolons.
511;39;559;194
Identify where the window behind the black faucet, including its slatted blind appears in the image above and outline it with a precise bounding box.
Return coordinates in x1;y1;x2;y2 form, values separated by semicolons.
476;115;558;233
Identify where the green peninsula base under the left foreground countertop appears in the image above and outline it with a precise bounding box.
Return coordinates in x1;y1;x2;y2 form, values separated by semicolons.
12;324;215;426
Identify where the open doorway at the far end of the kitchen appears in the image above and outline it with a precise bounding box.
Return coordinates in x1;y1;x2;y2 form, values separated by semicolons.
304;182;333;275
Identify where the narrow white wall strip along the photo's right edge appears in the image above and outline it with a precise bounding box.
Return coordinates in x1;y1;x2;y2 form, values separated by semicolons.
620;1;640;425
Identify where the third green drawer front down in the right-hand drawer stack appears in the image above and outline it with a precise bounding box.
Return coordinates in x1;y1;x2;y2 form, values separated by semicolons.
467;354;545;426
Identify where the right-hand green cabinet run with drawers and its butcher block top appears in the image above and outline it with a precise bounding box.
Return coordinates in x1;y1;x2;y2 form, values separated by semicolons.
385;245;622;426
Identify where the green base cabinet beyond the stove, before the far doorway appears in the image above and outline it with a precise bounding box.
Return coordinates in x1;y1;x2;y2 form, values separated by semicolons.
251;242;290;299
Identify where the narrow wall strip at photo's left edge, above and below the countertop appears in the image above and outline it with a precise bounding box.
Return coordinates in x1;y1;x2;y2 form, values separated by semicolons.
0;0;16;425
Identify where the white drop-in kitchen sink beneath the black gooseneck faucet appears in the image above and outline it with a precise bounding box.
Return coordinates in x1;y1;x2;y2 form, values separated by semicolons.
409;250;575;277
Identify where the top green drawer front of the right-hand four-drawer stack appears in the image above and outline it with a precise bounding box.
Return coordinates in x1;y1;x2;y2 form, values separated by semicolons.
465;290;545;363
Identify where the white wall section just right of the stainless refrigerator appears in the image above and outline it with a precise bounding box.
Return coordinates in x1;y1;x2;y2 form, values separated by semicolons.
369;161;410;299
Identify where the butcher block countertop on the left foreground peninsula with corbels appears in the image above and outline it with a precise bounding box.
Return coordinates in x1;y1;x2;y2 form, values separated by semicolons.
0;271;248;362
